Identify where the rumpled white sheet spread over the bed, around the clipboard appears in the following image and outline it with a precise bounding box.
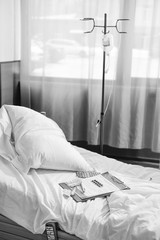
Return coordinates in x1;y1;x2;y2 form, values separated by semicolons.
0;148;160;240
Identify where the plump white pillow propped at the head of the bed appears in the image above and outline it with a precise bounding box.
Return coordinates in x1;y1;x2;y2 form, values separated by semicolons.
5;105;93;173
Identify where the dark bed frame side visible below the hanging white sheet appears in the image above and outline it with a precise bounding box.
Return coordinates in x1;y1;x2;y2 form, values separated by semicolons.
0;215;81;240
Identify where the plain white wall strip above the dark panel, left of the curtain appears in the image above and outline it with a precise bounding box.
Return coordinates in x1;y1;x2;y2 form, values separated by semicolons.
0;0;20;62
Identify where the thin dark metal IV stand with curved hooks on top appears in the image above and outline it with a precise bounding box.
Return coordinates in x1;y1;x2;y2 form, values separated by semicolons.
80;13;129;155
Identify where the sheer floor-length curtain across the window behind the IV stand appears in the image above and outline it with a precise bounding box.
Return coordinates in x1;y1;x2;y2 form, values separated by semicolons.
21;0;160;152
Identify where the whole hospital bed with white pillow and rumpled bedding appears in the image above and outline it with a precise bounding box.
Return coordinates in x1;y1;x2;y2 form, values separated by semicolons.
0;105;160;240
